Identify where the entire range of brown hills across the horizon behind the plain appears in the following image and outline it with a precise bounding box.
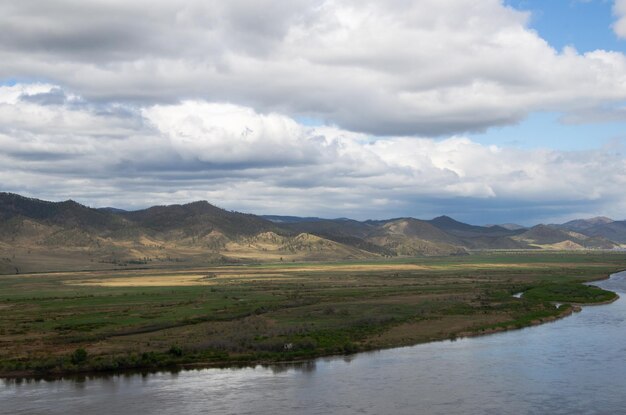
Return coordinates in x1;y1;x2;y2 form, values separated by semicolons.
0;193;626;274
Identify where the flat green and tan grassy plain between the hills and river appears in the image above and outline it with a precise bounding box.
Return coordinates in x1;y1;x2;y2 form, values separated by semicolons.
0;252;626;376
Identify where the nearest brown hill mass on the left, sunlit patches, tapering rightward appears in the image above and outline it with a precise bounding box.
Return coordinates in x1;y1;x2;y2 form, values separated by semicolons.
0;193;376;272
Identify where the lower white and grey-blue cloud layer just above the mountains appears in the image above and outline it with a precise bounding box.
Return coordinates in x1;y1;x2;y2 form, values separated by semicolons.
0;85;626;224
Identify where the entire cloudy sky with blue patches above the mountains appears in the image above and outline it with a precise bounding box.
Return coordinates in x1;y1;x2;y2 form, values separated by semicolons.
0;0;626;224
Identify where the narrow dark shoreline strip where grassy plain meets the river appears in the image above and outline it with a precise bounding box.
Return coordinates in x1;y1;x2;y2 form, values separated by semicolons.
0;269;626;382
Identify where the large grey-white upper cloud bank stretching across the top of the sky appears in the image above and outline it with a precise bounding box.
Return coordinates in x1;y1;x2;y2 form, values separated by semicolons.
0;0;626;135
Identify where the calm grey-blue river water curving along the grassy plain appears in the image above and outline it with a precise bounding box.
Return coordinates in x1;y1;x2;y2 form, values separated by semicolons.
0;273;626;415
